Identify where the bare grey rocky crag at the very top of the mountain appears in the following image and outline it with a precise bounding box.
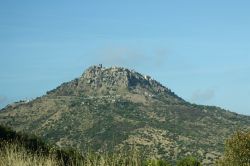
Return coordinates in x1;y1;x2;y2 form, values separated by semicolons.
81;64;168;92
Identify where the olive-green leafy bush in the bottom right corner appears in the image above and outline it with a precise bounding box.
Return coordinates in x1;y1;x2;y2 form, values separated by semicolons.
217;130;250;166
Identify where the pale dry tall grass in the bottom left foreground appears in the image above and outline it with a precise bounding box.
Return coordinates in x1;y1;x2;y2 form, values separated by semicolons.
0;142;146;166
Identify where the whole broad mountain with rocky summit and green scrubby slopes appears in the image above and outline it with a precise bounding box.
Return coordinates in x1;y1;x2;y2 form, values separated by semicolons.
0;65;250;165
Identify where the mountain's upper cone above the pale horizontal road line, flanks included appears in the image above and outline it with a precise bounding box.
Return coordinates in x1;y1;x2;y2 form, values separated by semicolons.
50;65;184;102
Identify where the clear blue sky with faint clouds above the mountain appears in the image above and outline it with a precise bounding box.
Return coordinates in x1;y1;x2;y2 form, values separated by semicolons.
0;0;250;115
